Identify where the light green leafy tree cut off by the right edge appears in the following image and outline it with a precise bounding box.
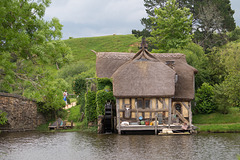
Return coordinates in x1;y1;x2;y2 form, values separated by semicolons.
214;42;240;113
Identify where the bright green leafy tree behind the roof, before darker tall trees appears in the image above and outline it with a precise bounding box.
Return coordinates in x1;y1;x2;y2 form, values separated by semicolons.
149;0;192;52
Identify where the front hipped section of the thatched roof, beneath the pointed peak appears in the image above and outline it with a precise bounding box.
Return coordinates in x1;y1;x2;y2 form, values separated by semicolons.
112;49;176;97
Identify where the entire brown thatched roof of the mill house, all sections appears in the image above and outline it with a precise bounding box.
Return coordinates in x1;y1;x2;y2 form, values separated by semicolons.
96;48;197;100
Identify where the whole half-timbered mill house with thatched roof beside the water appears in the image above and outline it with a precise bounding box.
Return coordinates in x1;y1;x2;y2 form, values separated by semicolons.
96;39;197;134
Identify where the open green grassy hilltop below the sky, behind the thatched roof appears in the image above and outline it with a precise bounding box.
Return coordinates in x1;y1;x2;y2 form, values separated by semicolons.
64;35;141;63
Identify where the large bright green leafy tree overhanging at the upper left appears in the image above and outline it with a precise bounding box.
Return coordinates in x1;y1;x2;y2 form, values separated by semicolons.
0;0;71;94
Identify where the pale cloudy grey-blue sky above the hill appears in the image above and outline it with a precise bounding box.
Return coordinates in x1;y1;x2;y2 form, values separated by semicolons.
44;0;240;39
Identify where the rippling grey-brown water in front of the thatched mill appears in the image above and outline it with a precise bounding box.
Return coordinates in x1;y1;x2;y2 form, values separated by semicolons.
0;132;240;160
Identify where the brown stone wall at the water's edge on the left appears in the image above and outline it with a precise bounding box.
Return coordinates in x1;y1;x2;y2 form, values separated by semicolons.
0;93;46;131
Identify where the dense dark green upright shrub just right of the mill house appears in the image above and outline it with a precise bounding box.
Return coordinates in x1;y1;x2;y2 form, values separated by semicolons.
196;83;217;114
